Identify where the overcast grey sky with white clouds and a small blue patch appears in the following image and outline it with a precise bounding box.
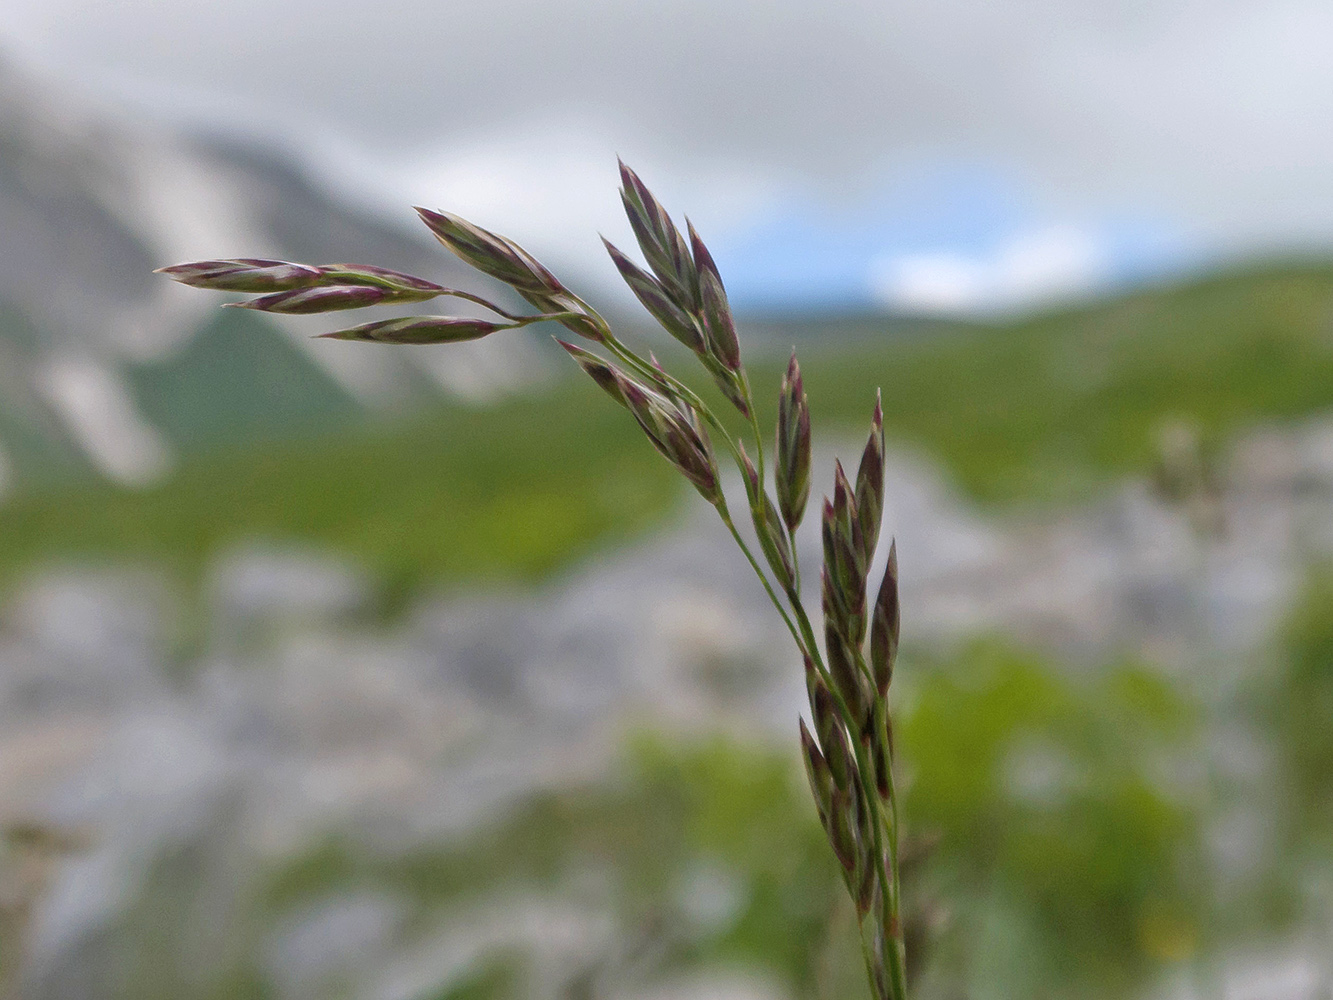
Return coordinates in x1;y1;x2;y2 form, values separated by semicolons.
0;0;1333;309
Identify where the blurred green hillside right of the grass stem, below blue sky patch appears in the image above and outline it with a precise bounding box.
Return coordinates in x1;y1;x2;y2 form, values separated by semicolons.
778;268;1333;504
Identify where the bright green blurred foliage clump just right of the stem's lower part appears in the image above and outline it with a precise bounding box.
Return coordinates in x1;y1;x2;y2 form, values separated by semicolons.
898;643;1206;997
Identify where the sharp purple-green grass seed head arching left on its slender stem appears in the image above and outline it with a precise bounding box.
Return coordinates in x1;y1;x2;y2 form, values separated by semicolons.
153;164;906;1000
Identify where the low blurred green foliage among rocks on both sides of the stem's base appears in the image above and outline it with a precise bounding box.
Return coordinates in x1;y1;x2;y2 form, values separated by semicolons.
83;644;1208;1000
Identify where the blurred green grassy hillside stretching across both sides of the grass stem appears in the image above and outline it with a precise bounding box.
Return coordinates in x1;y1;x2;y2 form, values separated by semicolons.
0;268;1333;600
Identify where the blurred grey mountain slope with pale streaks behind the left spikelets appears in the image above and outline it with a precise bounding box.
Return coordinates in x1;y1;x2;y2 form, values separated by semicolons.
0;59;536;493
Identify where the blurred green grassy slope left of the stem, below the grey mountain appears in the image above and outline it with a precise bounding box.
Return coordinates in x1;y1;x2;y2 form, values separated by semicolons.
0;387;677;595
